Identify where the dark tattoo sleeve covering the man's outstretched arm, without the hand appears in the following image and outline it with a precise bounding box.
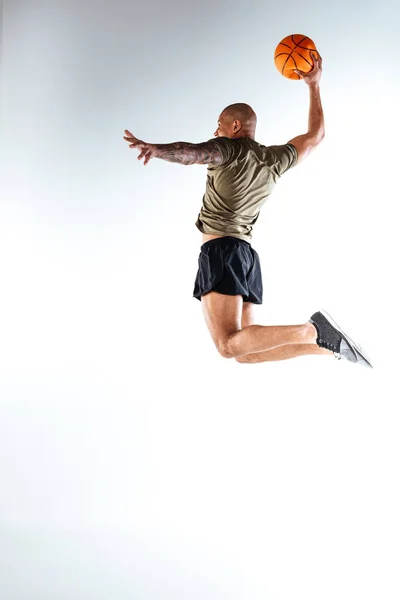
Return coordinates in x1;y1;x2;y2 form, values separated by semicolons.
152;142;222;166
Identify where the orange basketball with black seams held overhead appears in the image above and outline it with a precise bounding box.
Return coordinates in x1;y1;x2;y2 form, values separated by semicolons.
274;33;317;79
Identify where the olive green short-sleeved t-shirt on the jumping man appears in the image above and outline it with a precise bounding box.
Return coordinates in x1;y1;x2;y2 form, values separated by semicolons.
196;137;297;241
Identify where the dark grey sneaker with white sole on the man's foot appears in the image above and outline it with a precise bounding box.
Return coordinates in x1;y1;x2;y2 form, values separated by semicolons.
310;310;372;369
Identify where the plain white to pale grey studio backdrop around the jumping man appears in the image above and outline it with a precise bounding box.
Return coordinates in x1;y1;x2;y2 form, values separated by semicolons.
0;0;400;600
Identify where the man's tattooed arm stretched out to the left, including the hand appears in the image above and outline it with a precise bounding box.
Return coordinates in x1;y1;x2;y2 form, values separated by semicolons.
124;129;222;166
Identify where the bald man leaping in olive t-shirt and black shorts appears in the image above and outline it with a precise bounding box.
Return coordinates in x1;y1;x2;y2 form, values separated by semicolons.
124;53;372;367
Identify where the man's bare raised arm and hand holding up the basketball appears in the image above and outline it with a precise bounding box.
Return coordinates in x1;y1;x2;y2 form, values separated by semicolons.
288;52;325;163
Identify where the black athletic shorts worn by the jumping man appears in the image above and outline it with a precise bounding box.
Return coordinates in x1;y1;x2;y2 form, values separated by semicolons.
193;236;263;304
